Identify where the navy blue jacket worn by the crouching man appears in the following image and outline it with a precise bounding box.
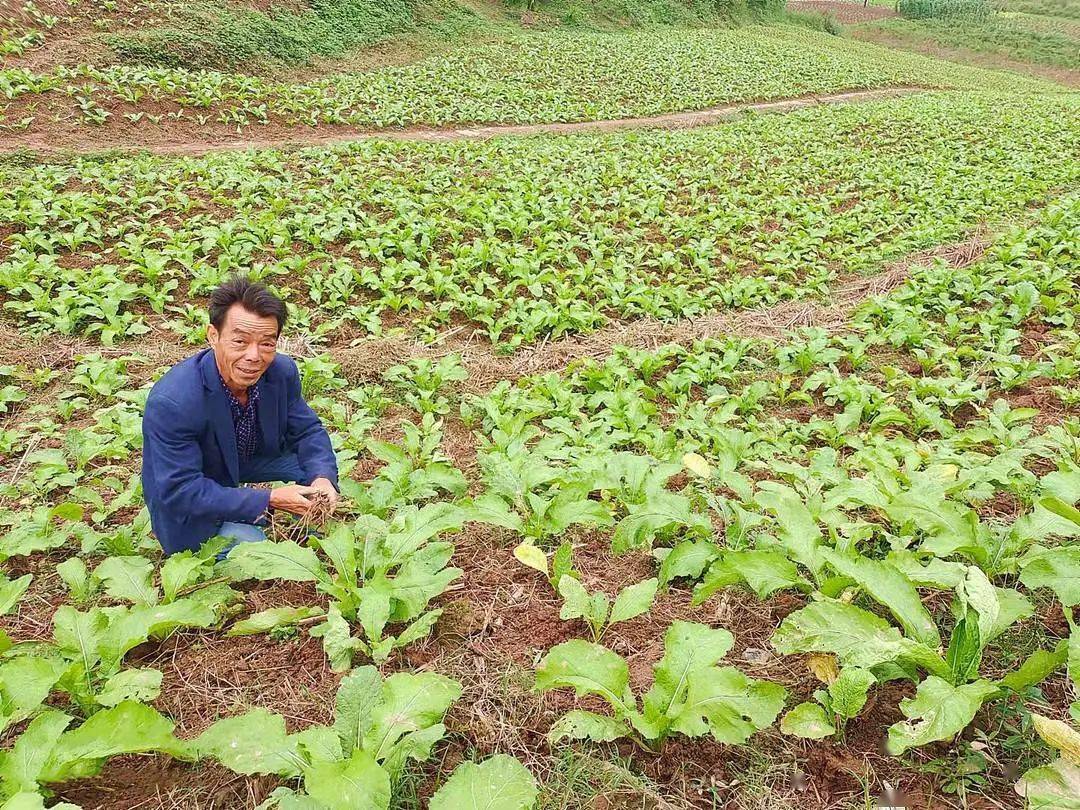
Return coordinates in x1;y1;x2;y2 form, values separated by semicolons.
143;349;337;554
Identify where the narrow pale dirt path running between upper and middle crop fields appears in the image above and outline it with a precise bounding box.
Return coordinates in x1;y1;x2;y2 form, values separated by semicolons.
6;85;929;156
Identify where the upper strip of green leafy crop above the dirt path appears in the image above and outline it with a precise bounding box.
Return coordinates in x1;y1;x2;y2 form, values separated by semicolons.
0;26;1052;138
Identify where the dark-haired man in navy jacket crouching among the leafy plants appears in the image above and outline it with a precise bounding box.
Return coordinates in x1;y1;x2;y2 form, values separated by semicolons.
143;276;338;554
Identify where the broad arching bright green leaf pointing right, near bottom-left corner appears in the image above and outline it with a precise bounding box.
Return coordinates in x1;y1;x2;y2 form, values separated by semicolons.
41;701;190;782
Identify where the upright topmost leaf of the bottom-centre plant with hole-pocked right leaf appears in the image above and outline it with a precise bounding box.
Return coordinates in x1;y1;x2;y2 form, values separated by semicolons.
645;621;734;720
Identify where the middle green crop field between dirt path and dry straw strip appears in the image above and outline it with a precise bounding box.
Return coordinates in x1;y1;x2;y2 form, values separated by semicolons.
0;94;1078;351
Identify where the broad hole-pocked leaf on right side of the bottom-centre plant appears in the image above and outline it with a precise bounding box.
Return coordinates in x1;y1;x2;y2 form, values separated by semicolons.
670;666;787;745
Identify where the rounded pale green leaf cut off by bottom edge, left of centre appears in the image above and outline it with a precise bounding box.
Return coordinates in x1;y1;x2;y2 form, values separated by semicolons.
429;754;540;810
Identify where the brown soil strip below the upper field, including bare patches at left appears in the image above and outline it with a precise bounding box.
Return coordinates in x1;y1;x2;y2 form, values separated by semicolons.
0;86;923;154
